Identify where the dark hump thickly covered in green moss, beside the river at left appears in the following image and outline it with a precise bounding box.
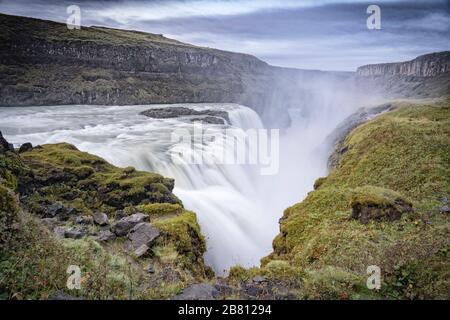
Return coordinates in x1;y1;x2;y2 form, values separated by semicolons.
18;143;180;213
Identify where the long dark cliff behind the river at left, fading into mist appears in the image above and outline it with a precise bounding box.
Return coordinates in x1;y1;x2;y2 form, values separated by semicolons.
0;15;351;126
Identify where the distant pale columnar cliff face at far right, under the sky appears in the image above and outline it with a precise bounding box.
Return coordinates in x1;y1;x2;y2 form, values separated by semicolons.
356;51;450;77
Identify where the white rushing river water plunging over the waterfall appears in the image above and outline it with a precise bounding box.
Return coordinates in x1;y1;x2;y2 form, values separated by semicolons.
0;103;358;274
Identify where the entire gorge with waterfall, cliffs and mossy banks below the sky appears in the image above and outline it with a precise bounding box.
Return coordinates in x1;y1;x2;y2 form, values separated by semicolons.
0;14;450;299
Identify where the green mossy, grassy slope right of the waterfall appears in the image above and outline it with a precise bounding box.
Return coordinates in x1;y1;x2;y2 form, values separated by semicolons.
237;100;450;299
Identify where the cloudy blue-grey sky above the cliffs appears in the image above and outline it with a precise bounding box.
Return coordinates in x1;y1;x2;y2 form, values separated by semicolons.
0;0;450;71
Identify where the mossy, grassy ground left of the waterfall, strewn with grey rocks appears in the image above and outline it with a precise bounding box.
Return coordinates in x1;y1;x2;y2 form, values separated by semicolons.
0;143;211;299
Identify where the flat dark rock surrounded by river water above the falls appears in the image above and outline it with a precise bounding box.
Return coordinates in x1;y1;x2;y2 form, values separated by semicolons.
140;107;230;124
